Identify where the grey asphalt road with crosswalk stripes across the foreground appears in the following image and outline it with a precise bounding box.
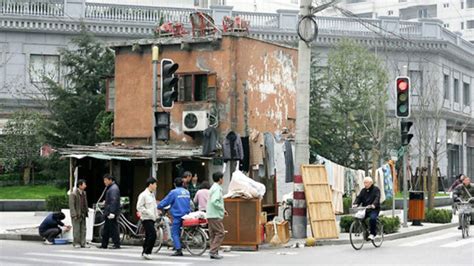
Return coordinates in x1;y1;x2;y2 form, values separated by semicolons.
0;228;474;266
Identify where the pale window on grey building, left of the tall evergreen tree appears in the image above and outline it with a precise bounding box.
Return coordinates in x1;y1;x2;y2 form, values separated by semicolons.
29;54;60;83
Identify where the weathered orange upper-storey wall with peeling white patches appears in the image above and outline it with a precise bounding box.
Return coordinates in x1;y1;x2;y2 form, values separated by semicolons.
114;36;297;144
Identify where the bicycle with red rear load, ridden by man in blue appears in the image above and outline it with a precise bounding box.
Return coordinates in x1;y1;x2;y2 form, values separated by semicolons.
155;214;208;256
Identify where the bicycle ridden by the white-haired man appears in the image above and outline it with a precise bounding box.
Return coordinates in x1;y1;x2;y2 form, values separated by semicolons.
349;207;384;250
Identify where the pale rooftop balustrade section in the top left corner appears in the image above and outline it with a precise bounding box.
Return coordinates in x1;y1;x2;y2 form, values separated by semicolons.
0;0;64;17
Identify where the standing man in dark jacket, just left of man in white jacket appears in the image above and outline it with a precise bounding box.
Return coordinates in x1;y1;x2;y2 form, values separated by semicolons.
100;174;120;249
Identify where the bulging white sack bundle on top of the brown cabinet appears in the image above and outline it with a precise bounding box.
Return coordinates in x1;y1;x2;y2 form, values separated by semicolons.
224;170;266;199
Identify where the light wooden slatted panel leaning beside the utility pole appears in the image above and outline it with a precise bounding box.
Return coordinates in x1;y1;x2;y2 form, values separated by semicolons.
301;165;339;239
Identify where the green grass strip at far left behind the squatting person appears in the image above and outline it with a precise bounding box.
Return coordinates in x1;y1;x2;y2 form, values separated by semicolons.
0;185;66;199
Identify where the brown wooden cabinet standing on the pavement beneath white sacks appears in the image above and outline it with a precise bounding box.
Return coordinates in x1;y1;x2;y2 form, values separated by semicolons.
223;198;262;247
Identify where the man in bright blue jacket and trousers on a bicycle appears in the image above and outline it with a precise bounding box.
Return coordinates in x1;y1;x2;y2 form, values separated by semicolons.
158;177;191;256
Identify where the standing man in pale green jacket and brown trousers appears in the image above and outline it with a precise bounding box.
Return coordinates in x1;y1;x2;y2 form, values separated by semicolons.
206;172;227;259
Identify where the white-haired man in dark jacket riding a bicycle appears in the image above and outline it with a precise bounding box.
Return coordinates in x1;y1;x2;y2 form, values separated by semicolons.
352;177;380;240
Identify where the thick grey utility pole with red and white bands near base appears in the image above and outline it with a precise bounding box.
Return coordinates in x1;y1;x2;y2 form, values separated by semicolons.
291;0;312;238
